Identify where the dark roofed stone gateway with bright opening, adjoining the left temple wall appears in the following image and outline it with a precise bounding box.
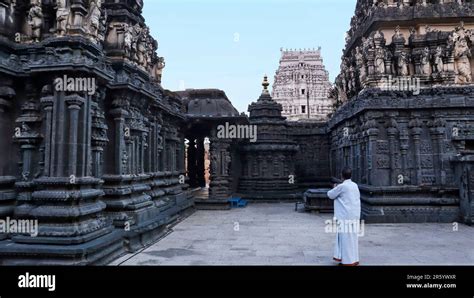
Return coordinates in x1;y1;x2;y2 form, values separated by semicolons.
177;89;248;209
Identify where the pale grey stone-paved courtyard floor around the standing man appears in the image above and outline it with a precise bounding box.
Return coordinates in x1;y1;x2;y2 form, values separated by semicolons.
112;203;474;265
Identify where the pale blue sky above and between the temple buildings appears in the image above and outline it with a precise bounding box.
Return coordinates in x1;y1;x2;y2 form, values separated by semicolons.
143;0;356;112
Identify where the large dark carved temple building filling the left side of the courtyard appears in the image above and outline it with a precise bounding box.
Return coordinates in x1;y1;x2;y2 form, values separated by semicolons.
0;0;193;265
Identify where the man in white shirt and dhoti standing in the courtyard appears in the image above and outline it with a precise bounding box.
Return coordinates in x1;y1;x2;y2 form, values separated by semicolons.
328;168;360;266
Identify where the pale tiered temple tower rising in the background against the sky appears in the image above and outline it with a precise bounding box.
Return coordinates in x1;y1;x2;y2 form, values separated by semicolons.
272;48;334;121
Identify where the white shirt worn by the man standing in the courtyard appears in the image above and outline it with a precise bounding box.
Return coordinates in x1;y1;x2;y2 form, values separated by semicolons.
328;179;360;220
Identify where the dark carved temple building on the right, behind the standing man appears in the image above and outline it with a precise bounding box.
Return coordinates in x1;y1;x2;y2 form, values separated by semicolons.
328;0;474;222
